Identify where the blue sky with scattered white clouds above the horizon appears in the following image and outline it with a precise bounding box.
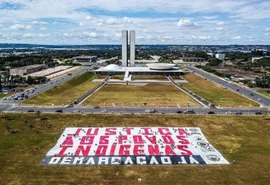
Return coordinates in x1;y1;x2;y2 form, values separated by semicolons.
0;0;270;45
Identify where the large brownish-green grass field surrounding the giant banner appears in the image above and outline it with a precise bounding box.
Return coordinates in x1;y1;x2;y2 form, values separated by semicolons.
0;114;270;185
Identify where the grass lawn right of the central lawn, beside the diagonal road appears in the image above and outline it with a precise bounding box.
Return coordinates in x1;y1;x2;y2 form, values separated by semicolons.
183;73;259;107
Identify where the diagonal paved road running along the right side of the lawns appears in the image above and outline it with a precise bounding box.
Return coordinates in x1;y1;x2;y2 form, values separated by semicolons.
187;67;270;107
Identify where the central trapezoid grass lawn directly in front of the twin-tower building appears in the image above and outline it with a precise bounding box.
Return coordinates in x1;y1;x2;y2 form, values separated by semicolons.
84;84;200;107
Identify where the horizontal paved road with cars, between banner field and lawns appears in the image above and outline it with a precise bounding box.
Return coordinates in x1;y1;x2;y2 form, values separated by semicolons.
1;106;269;115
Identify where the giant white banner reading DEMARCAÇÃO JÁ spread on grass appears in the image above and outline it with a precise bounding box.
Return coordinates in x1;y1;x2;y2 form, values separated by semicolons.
42;127;228;165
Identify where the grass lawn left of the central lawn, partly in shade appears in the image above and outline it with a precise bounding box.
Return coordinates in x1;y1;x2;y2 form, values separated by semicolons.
24;72;97;105
